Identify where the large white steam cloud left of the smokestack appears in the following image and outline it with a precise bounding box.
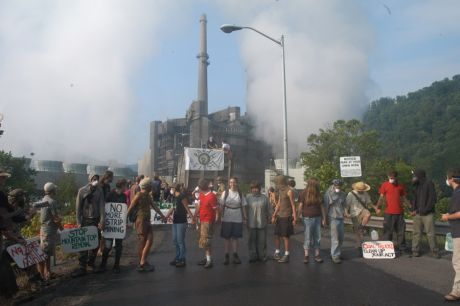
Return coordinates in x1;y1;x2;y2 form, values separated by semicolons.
0;0;177;162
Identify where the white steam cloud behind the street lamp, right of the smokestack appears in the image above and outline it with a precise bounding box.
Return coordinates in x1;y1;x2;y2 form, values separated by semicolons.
216;0;373;158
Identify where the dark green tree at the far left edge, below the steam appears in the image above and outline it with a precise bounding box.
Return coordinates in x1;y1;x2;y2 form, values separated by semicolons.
0;151;35;194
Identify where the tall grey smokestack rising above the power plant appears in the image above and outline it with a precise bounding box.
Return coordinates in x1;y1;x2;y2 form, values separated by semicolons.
187;14;209;148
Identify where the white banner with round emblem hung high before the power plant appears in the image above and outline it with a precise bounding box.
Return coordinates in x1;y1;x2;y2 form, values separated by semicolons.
184;148;224;171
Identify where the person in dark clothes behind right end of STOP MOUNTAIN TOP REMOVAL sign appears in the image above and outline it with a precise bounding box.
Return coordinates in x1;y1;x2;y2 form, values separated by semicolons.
72;174;105;277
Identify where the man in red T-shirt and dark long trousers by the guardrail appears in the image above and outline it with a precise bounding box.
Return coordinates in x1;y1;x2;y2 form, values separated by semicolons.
376;170;409;253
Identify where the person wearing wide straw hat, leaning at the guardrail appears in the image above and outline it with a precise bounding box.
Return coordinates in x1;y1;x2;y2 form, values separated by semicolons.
345;182;375;255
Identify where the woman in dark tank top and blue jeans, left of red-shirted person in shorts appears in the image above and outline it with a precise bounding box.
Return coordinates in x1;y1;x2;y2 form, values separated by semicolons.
166;184;195;268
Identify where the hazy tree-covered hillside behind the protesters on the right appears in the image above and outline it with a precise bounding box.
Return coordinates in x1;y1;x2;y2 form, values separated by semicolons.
363;75;460;182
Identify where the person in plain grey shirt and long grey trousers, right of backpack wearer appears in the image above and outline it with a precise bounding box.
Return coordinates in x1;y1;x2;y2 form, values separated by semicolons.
246;181;270;263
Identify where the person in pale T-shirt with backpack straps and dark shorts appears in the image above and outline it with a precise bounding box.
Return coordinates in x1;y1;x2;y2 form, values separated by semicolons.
219;177;248;265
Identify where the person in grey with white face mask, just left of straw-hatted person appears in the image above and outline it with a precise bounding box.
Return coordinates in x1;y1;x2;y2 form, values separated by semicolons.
323;179;347;264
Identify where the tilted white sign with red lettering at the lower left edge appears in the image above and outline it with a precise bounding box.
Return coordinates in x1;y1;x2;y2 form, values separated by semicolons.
6;237;46;269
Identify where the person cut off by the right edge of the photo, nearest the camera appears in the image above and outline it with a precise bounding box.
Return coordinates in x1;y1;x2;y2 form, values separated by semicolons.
441;168;460;301
